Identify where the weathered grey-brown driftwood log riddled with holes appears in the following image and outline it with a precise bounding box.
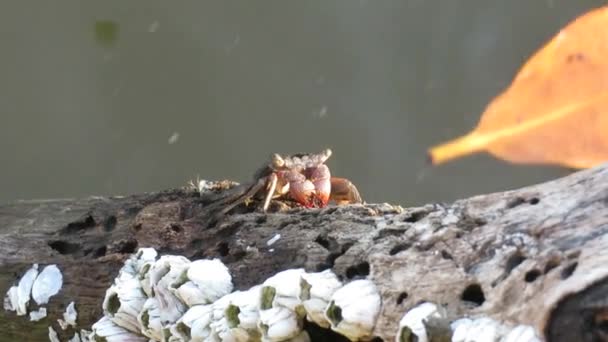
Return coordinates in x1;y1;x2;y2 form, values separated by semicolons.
0;165;608;341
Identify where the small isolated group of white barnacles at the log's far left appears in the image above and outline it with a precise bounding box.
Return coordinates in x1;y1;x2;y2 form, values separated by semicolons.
4;264;63;321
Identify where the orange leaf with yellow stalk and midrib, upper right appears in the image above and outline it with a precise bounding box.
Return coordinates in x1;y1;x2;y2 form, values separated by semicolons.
429;7;608;168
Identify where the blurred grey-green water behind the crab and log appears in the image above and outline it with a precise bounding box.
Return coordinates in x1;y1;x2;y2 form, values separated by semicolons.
0;0;604;205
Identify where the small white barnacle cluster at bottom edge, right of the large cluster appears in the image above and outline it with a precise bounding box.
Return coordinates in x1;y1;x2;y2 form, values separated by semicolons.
395;302;541;342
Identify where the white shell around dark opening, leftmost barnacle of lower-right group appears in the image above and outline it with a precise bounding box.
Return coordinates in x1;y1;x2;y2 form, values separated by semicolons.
395;302;447;342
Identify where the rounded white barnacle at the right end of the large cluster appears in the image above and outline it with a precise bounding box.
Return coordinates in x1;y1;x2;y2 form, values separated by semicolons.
325;279;381;341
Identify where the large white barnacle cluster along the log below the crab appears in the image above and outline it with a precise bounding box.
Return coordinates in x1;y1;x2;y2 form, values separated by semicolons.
89;249;381;342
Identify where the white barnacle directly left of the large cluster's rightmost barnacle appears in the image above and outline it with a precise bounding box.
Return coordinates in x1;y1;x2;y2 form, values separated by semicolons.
298;270;342;328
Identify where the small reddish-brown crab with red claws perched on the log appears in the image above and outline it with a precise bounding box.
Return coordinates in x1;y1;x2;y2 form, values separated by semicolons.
217;149;362;213
